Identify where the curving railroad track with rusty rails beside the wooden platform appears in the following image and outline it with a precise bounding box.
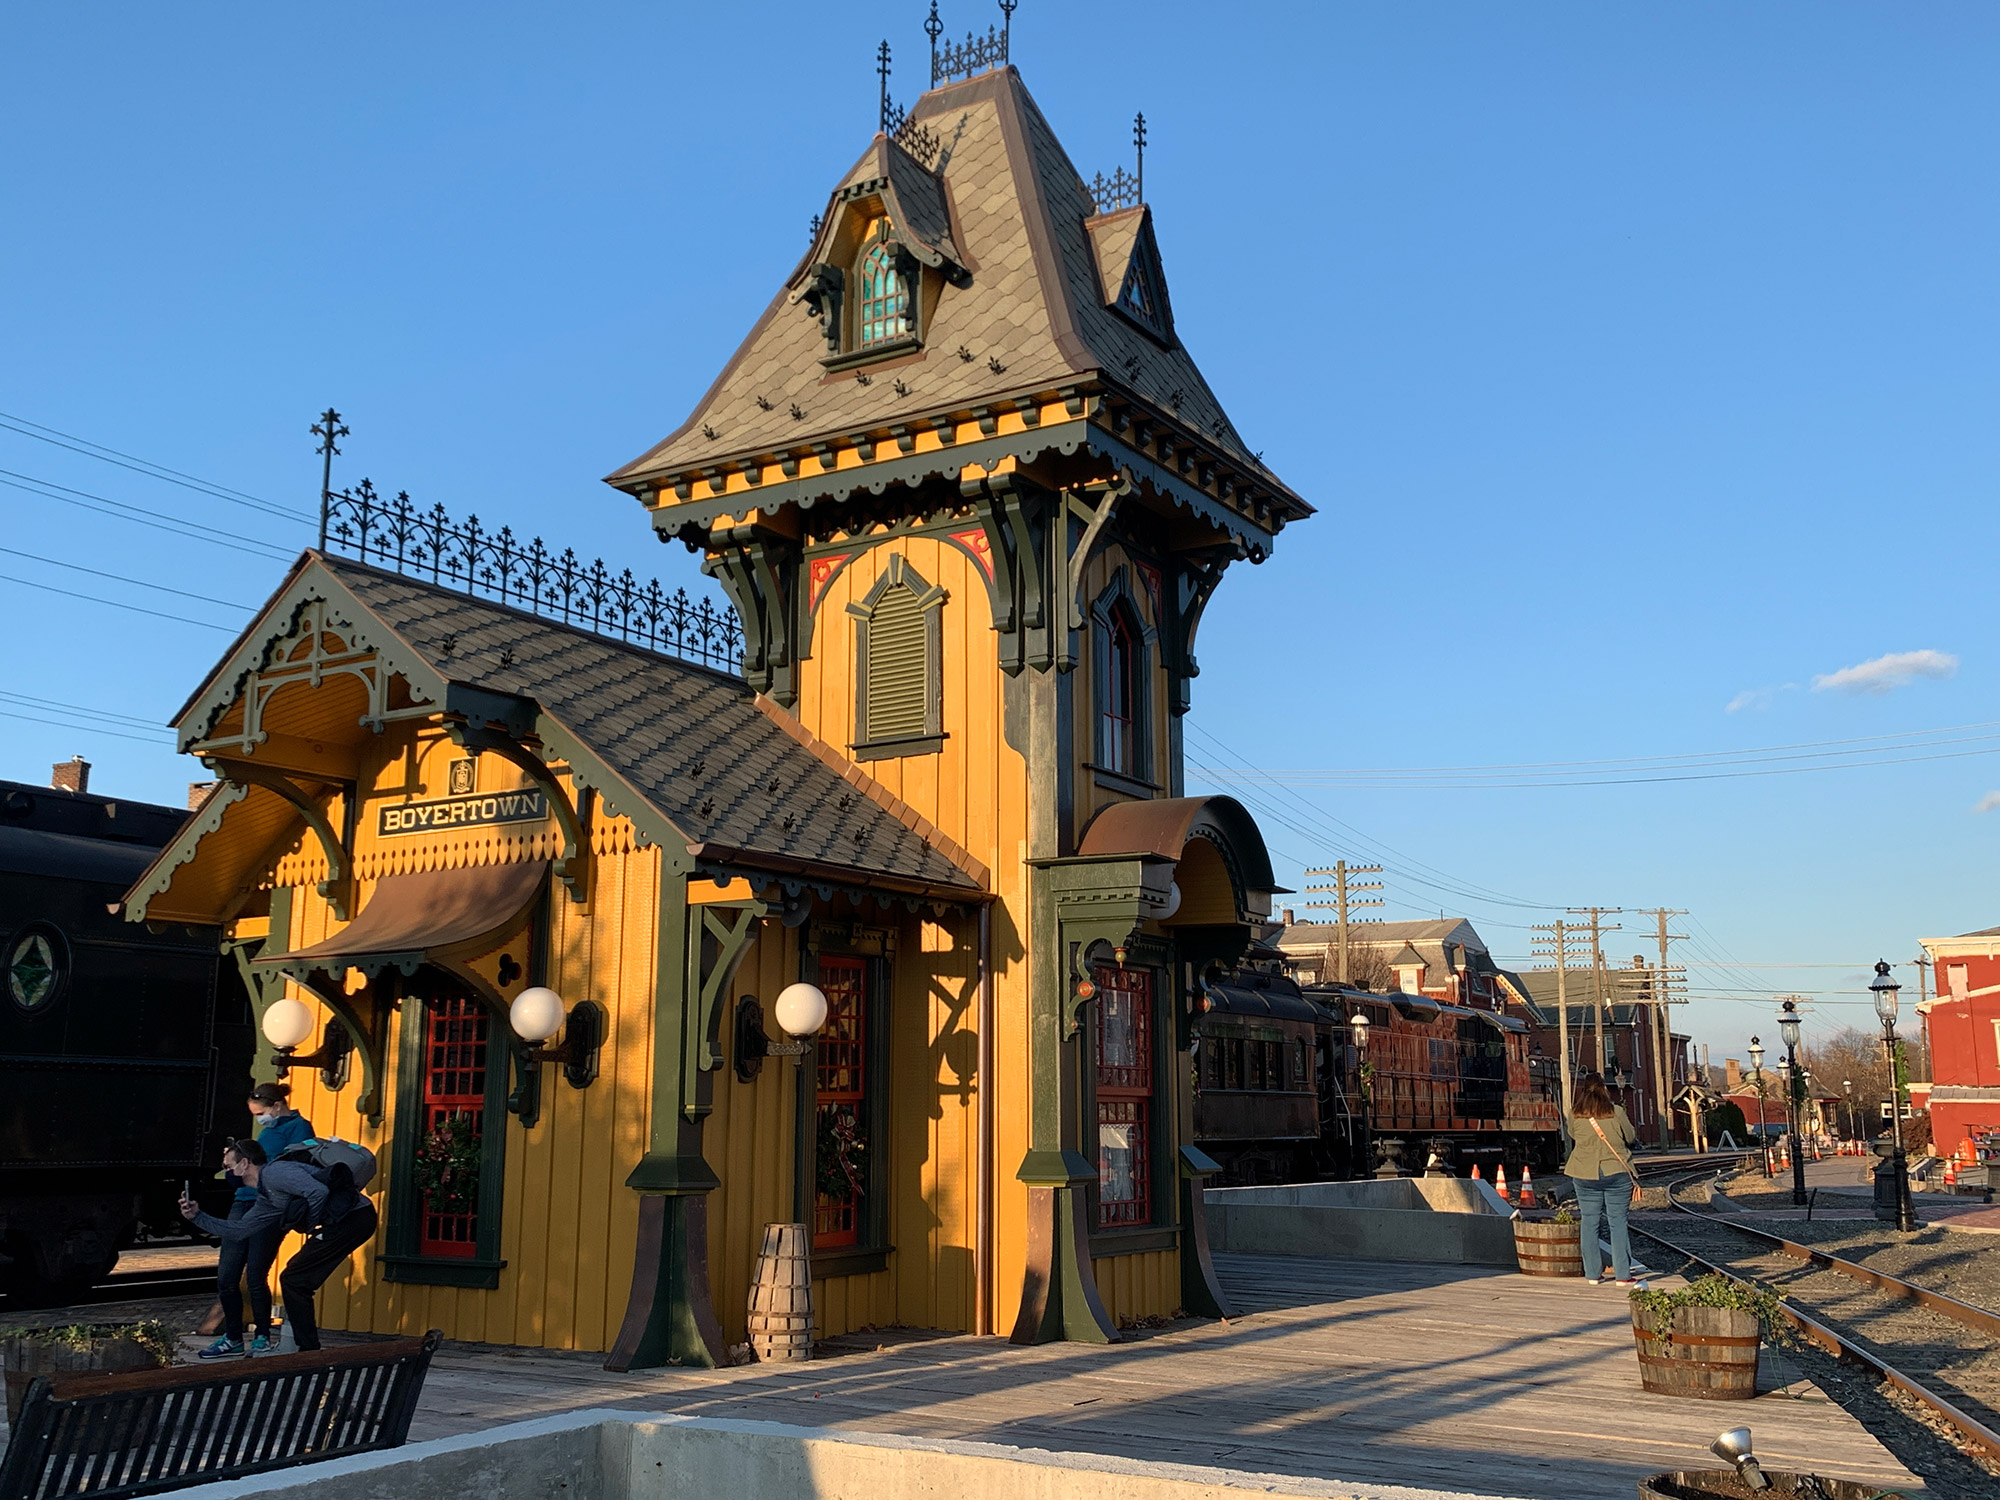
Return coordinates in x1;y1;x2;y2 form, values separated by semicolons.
1632;1168;2000;1460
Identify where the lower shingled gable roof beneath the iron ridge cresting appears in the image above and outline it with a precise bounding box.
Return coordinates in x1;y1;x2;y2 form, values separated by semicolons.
178;552;988;900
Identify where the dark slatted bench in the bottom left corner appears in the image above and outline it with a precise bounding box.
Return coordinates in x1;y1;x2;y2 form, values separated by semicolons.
0;1330;444;1500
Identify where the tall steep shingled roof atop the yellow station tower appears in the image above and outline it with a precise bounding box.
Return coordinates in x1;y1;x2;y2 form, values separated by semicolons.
608;68;1312;530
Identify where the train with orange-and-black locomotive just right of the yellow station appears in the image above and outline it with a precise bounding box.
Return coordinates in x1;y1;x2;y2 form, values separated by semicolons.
1194;966;1562;1186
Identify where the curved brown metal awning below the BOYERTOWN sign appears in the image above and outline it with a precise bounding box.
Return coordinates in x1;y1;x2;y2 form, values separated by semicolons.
256;860;548;974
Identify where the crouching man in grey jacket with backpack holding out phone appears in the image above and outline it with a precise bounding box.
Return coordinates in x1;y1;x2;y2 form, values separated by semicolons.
180;1140;376;1350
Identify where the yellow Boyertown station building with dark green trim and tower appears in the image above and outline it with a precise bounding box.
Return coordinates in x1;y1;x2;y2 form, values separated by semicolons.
124;50;1310;1368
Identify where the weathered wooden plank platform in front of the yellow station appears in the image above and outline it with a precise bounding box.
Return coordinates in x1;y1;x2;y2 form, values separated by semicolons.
364;1256;1916;1500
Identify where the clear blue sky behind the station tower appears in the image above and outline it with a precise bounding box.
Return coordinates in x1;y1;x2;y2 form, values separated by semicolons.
0;0;2000;1058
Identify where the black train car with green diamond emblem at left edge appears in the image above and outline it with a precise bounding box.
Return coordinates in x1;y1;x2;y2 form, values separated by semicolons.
0;782;254;1306
